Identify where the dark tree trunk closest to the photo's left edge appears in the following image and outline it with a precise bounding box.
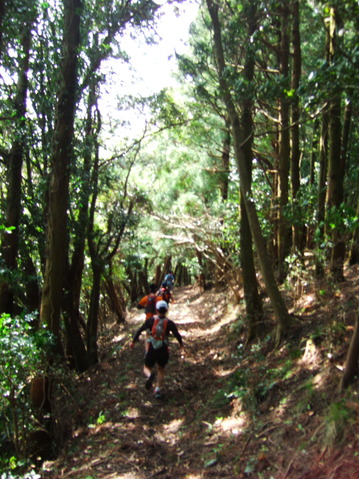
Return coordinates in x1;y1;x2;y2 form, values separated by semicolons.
0;18;32;314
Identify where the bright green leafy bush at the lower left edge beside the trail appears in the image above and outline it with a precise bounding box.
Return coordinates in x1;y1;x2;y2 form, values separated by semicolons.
0;314;53;457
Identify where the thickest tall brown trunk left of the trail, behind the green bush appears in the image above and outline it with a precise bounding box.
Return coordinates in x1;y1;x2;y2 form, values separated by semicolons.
40;0;82;341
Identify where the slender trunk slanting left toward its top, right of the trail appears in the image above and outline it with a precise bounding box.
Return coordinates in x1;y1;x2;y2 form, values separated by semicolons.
207;0;290;344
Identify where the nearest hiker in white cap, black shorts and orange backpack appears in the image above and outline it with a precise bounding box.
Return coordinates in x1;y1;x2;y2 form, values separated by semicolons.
130;300;183;399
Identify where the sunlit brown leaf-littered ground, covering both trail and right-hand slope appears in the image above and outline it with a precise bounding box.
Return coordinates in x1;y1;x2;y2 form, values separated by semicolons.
44;268;359;479
